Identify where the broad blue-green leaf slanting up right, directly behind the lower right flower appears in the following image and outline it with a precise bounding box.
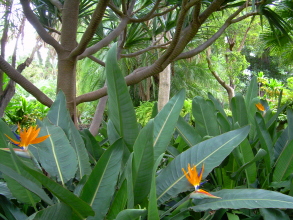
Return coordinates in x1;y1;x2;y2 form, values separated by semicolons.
157;126;249;203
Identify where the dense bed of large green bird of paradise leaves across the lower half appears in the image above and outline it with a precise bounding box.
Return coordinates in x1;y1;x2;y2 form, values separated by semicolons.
0;47;293;220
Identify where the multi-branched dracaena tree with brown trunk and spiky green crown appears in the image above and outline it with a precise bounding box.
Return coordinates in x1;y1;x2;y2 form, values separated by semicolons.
0;0;289;124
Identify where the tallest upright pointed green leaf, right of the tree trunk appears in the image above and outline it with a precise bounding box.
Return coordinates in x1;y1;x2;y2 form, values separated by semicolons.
106;44;139;151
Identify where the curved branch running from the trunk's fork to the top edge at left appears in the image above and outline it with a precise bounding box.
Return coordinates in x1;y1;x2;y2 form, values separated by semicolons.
20;0;63;53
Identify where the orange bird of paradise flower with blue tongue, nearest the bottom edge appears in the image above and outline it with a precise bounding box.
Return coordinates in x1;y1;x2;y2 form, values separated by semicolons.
182;164;220;199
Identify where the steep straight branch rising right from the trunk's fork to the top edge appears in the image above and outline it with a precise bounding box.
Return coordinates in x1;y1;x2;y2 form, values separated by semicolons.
70;0;110;57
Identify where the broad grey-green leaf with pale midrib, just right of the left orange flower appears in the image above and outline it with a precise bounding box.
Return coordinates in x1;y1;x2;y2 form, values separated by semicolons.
29;124;78;185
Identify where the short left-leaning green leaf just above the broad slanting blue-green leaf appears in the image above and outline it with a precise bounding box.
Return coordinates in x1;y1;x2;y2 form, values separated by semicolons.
176;116;202;147
